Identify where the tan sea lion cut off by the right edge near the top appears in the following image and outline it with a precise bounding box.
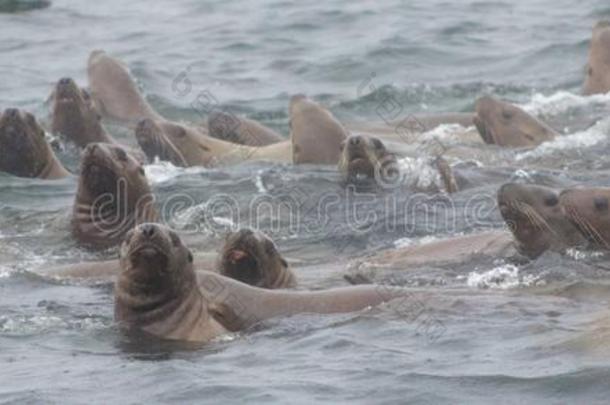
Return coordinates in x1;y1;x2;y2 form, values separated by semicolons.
583;21;610;96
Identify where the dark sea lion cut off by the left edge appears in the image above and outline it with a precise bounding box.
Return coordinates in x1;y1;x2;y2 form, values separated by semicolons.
0;108;70;179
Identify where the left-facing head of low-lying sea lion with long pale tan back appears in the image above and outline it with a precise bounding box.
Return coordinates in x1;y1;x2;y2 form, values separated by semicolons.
135;118;187;167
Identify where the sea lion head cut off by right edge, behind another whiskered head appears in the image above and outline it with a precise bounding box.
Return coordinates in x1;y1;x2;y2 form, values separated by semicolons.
559;187;610;250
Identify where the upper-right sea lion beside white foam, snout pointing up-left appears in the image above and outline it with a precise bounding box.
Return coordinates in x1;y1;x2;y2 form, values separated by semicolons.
473;96;559;147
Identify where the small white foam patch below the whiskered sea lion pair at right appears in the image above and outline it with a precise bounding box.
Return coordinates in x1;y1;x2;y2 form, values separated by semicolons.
466;264;543;290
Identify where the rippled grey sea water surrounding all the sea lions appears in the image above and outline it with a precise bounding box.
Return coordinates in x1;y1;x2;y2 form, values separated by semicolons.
0;0;610;404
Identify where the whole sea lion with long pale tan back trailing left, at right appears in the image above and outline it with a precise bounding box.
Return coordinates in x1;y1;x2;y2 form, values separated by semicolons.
350;183;586;274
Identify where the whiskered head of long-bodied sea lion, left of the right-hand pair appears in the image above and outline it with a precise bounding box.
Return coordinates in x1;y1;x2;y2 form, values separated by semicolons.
498;183;585;258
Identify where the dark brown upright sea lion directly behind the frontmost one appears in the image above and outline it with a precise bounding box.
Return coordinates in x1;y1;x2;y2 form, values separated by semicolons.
72;143;158;248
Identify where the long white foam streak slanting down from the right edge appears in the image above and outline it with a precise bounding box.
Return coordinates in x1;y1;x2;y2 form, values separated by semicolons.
515;119;610;160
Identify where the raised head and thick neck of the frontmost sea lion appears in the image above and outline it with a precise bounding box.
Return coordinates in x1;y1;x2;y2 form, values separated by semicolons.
114;223;227;342
